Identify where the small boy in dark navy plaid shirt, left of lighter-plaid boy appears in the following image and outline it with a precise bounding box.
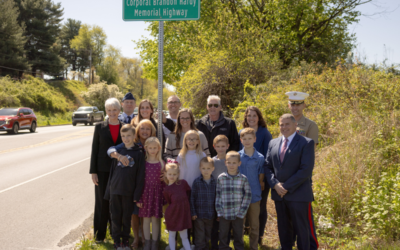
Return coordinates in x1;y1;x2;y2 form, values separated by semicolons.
190;157;217;250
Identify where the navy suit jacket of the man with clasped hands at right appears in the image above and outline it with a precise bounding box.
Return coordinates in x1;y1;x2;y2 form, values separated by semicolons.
265;133;315;202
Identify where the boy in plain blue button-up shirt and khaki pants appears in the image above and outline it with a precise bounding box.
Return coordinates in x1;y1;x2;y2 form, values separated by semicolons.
239;128;265;250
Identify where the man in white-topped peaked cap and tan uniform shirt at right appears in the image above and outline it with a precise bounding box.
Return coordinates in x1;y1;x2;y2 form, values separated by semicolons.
285;91;318;249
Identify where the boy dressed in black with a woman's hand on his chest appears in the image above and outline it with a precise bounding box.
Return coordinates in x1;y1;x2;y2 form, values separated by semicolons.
104;124;145;250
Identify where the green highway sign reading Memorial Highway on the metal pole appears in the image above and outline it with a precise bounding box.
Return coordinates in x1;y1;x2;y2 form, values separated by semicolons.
122;0;200;21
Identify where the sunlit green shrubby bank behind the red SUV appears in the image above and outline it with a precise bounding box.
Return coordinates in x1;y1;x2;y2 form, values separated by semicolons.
0;76;87;126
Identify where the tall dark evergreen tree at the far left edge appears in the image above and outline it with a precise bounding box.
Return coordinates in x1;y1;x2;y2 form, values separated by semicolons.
0;0;30;76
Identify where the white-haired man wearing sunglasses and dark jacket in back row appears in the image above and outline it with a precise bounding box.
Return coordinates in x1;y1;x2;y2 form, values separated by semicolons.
196;95;240;157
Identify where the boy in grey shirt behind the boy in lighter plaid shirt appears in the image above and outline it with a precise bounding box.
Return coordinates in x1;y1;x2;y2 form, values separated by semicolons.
211;135;230;250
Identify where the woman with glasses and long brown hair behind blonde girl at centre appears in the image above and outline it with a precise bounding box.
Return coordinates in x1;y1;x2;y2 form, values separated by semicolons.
165;108;210;159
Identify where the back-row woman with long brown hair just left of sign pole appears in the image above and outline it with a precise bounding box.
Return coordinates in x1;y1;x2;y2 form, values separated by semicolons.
131;99;175;152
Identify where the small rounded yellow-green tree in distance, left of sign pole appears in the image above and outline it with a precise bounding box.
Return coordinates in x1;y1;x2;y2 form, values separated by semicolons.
97;45;121;84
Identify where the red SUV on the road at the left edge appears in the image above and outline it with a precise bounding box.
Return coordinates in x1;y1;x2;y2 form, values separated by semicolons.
0;108;37;134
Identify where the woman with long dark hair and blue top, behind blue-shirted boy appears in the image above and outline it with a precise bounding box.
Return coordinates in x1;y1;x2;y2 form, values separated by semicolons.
239;106;272;244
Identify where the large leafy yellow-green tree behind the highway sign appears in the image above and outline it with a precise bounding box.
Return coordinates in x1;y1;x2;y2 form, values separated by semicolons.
137;0;371;84
